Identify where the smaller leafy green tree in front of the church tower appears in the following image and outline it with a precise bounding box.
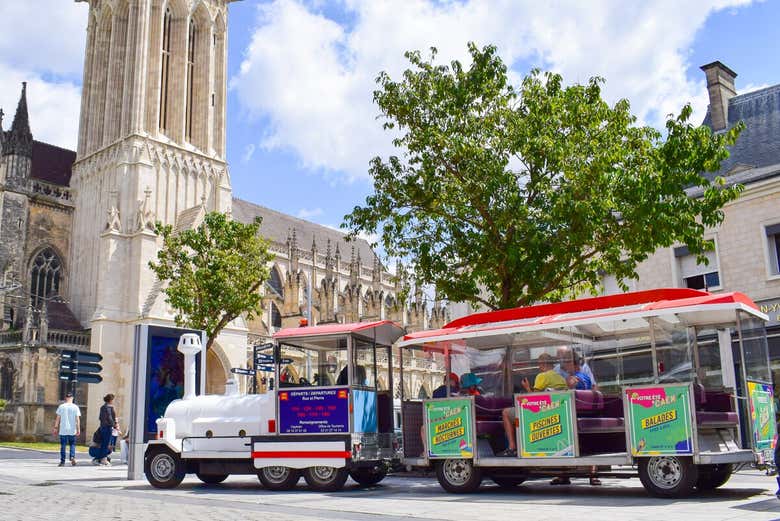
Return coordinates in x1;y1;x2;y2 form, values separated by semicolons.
149;212;273;349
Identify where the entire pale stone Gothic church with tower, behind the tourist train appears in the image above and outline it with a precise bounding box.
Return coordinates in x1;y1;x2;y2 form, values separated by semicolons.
0;0;447;437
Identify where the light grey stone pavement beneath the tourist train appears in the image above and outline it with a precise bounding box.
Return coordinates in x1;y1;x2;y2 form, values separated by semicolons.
0;448;780;521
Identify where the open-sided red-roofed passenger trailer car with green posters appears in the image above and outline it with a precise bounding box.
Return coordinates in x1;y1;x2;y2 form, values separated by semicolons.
398;289;777;497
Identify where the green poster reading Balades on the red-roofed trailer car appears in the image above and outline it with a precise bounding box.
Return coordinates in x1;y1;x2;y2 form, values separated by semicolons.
625;384;693;456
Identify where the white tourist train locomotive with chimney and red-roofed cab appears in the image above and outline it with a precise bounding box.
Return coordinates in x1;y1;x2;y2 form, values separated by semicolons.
144;321;403;491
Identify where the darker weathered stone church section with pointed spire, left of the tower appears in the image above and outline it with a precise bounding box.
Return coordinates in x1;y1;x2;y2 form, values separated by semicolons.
0;85;89;438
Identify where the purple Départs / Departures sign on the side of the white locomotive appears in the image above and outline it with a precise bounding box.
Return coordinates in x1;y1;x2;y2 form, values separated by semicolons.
279;387;349;434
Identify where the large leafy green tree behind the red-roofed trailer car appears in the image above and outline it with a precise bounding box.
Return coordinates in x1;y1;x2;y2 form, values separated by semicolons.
344;44;742;309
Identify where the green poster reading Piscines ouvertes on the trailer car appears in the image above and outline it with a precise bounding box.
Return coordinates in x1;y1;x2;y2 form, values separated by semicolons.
515;391;577;458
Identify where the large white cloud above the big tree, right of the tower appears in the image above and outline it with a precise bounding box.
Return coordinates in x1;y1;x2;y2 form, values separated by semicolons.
231;0;749;183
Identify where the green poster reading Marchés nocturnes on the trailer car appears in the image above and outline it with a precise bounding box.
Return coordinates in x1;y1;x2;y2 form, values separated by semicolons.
425;398;474;458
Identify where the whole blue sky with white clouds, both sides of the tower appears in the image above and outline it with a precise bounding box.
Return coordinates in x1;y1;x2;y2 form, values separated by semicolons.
0;0;780;235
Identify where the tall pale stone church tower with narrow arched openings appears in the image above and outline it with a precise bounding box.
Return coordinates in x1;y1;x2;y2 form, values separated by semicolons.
69;0;241;418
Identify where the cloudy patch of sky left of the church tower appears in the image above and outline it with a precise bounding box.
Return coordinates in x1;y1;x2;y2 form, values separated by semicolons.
0;0;88;148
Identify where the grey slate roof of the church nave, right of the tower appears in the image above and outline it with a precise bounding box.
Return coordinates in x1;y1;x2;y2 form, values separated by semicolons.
233;197;374;266
